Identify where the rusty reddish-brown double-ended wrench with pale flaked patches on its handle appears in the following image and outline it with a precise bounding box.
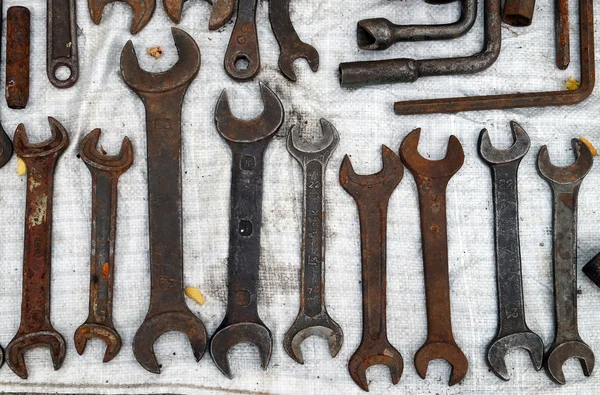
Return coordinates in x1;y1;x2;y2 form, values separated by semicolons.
6;117;69;379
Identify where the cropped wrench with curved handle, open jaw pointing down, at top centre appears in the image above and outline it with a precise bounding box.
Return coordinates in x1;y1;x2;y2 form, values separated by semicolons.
269;0;319;81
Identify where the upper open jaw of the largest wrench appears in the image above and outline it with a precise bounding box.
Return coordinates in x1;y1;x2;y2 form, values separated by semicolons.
121;27;200;93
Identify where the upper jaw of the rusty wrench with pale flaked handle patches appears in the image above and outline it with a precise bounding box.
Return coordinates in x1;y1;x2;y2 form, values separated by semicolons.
14;117;69;158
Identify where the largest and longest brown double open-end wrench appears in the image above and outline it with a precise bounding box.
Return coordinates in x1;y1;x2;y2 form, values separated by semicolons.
121;28;207;373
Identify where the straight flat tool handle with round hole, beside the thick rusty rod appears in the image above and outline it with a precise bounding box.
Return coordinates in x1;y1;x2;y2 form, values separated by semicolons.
46;0;79;88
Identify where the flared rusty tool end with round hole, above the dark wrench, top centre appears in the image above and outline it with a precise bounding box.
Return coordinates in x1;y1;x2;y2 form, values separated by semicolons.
223;0;260;81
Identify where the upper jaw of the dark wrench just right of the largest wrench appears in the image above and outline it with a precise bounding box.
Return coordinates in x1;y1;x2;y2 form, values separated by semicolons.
215;82;284;143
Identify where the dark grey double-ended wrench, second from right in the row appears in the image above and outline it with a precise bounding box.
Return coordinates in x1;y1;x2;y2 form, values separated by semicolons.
479;121;544;380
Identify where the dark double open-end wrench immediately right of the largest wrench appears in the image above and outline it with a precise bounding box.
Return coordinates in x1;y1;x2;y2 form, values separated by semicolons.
210;83;284;378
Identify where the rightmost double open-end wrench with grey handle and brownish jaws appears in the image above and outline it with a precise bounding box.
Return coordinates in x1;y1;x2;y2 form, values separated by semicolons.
537;139;595;384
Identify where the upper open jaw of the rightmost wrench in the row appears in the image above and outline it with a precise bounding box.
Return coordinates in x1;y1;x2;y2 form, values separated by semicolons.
537;139;594;184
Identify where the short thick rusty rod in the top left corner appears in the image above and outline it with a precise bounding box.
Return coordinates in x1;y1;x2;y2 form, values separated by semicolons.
6;6;30;108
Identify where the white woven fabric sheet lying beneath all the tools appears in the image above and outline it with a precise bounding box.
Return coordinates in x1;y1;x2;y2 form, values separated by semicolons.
0;0;600;394
